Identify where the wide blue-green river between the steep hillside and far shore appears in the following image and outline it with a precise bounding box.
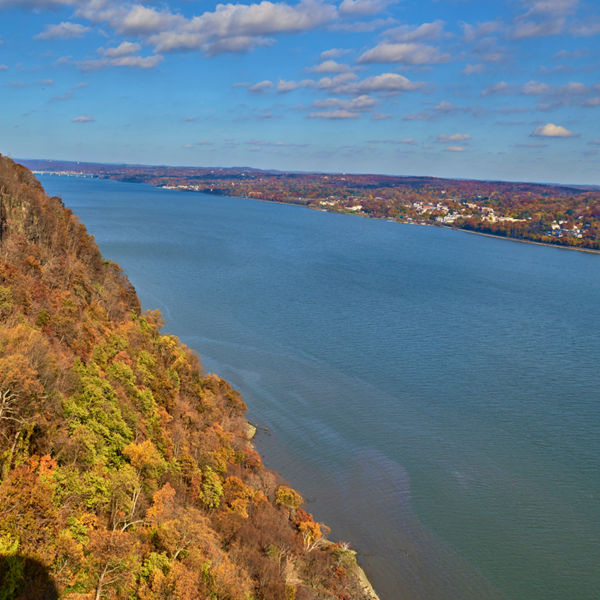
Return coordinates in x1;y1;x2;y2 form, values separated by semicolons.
41;176;600;600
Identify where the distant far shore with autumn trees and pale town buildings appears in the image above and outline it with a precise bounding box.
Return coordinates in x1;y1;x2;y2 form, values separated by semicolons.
21;160;600;250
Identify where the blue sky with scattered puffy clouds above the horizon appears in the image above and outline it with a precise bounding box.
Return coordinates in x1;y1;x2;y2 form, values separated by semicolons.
0;0;600;184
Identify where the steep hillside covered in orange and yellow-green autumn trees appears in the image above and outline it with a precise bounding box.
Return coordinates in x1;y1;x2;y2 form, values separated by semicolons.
0;156;374;600
